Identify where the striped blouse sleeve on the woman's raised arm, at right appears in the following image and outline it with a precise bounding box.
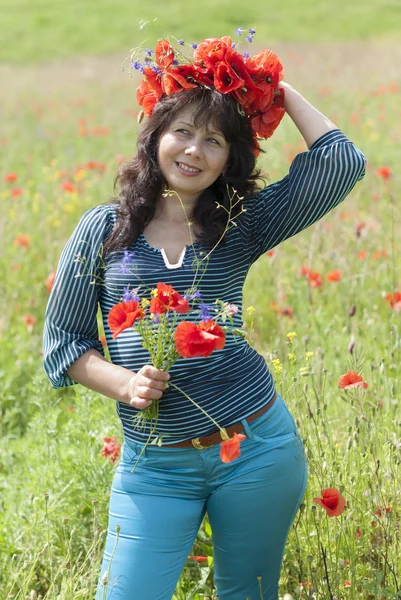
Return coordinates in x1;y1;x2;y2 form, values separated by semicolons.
238;129;366;263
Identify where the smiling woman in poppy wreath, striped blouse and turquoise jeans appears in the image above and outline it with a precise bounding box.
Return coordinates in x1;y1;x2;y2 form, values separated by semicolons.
44;38;366;600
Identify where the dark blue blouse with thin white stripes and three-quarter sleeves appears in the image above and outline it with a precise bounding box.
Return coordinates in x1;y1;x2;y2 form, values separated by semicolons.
44;129;366;444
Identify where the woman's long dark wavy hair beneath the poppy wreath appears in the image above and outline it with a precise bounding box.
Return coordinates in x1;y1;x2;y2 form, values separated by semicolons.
104;87;260;253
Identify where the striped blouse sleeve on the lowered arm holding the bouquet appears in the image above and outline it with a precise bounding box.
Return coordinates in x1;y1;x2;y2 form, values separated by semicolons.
43;205;112;388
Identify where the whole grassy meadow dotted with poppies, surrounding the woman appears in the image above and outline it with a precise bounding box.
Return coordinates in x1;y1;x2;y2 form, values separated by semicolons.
0;0;401;600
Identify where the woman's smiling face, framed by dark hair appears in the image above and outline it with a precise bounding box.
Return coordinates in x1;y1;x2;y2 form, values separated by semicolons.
158;105;230;201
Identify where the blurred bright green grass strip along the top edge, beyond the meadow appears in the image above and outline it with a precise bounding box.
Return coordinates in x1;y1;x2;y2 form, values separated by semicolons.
0;0;401;63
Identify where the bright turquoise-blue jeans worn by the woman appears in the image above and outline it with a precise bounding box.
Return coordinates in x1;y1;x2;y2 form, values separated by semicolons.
96;395;307;600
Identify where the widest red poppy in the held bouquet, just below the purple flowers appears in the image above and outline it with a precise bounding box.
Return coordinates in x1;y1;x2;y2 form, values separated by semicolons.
174;319;226;358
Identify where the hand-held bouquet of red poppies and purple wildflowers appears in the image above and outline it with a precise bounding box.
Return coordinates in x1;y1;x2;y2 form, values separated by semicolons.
108;274;243;462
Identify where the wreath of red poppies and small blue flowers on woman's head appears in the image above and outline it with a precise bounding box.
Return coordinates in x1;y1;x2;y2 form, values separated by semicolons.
131;30;285;144
